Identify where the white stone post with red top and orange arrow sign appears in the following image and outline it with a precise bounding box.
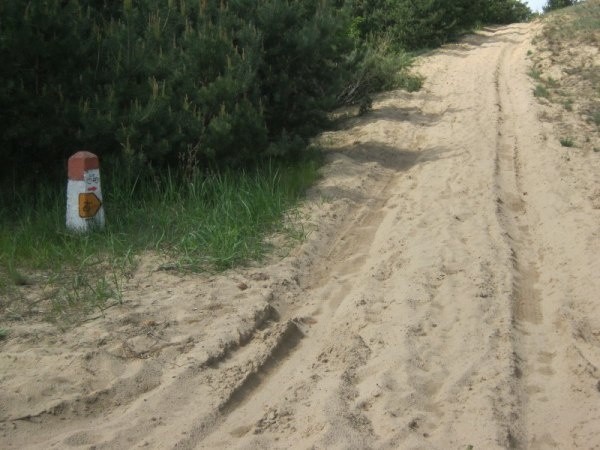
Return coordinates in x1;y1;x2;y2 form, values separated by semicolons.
67;152;104;233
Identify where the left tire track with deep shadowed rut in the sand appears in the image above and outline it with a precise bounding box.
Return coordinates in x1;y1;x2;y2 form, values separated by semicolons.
175;150;410;448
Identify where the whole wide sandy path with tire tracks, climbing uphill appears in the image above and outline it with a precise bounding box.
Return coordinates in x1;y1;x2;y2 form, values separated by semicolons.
0;25;600;449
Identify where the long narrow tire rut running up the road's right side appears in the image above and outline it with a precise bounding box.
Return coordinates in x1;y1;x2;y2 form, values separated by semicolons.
495;29;547;448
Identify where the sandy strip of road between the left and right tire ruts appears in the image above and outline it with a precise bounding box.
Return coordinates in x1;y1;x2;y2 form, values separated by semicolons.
196;24;536;448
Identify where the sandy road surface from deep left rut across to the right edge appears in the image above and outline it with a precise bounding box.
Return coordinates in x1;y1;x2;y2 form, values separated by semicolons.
190;25;600;449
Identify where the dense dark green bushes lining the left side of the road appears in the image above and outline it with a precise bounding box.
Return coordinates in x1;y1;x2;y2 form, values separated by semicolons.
0;0;536;184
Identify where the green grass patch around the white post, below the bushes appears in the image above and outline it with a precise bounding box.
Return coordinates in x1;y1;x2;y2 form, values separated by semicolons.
0;157;320;322
